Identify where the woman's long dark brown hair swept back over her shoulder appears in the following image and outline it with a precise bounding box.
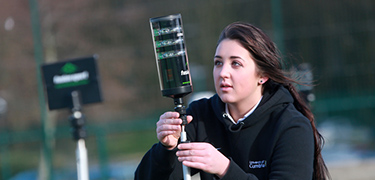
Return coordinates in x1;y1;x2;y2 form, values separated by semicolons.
218;22;330;180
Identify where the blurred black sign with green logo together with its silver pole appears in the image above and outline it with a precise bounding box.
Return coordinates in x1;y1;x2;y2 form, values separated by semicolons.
42;56;102;180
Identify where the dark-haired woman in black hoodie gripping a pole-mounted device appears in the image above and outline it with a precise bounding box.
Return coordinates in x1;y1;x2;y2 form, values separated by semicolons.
135;22;329;180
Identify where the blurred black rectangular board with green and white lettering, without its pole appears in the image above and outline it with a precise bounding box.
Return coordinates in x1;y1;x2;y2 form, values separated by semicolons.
42;55;102;110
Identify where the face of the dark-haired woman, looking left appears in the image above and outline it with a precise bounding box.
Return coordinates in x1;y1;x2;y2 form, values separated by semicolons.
213;39;268;106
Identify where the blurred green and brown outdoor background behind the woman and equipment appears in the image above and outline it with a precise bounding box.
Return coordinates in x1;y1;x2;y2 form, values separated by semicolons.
0;0;375;180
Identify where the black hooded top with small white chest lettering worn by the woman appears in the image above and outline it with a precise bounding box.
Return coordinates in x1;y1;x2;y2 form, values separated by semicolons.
135;86;314;180
